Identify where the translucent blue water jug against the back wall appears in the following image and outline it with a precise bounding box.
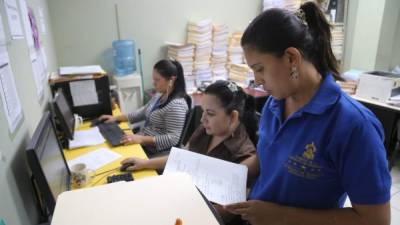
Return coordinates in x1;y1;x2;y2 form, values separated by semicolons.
112;40;136;76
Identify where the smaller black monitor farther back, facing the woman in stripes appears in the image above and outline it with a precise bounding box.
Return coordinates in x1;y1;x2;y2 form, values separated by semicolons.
53;88;75;140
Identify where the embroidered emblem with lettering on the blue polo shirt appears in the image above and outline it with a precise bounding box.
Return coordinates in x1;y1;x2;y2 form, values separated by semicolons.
285;142;323;180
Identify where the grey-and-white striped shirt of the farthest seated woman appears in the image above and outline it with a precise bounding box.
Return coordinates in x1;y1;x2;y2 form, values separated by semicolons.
128;94;189;152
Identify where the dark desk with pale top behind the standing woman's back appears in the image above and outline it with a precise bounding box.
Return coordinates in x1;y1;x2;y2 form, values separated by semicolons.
351;95;400;168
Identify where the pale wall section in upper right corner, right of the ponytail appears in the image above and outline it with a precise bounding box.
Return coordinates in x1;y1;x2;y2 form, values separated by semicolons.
344;0;400;71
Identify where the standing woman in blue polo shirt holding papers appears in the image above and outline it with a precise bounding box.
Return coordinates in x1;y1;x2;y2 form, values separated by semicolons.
225;2;391;225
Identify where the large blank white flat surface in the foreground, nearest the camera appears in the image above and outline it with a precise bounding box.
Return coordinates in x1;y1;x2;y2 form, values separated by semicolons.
51;174;223;225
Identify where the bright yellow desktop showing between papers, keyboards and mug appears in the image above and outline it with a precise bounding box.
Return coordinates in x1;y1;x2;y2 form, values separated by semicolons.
64;108;157;187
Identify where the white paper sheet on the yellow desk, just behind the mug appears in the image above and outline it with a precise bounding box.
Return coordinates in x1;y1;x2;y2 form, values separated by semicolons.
68;148;122;170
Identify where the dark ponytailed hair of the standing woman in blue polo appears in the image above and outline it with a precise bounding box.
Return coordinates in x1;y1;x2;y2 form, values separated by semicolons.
241;2;342;80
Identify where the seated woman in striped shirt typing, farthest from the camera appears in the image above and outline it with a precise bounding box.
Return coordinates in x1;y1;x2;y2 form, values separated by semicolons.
100;59;190;155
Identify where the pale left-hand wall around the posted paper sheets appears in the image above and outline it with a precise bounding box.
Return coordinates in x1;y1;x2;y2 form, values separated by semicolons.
0;0;57;225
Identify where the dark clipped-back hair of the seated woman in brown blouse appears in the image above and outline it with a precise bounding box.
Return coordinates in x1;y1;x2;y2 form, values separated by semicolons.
204;80;258;143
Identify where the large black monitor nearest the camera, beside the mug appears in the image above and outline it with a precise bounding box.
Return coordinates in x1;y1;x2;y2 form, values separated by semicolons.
26;111;70;216
